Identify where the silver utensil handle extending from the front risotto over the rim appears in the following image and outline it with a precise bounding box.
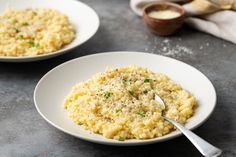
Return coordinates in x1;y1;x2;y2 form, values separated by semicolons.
164;117;222;157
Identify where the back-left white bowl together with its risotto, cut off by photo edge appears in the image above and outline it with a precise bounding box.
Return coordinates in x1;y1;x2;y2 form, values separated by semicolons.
0;0;99;62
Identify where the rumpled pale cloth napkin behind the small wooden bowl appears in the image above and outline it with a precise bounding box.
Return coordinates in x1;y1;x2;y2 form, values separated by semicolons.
130;0;236;44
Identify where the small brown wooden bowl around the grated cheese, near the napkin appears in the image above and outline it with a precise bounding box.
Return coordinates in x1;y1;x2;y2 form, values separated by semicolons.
143;2;185;36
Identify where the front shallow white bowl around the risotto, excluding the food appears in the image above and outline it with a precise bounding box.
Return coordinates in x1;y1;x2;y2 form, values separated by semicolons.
34;52;216;146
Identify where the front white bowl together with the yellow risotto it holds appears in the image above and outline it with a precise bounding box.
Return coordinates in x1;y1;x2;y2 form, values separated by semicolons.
34;51;216;146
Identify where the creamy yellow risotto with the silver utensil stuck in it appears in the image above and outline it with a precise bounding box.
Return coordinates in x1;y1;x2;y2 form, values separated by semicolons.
64;65;196;141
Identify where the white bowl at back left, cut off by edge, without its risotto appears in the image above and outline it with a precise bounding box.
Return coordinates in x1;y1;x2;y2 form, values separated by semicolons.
0;0;99;62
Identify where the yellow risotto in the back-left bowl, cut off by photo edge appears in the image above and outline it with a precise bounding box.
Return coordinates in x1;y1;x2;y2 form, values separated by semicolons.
0;8;75;56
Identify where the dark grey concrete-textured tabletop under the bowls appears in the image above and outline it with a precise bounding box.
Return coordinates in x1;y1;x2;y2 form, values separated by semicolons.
0;0;236;157
